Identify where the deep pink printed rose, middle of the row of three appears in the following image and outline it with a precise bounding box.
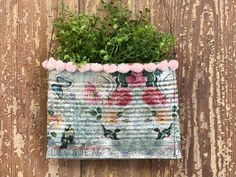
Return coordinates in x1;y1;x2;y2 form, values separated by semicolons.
107;87;132;106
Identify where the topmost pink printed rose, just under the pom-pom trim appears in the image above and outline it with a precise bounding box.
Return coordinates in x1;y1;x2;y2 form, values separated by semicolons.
126;72;147;87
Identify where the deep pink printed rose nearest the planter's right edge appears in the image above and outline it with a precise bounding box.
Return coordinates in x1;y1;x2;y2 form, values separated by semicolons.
142;87;167;105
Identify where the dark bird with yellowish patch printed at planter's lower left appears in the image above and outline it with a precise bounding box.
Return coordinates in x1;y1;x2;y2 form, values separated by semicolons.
60;125;75;149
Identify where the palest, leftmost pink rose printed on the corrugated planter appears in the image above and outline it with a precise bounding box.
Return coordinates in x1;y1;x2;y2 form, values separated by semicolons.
84;83;101;104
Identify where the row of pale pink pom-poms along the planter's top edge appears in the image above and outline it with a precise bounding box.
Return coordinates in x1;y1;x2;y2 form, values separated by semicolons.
42;57;179;73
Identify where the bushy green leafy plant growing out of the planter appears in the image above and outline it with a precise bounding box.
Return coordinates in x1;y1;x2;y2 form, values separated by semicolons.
54;0;175;64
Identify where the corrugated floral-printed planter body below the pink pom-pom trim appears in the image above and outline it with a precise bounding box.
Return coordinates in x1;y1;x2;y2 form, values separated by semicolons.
47;66;181;159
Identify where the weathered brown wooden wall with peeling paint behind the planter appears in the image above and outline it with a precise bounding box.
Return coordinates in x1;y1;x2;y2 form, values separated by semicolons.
0;0;236;177
